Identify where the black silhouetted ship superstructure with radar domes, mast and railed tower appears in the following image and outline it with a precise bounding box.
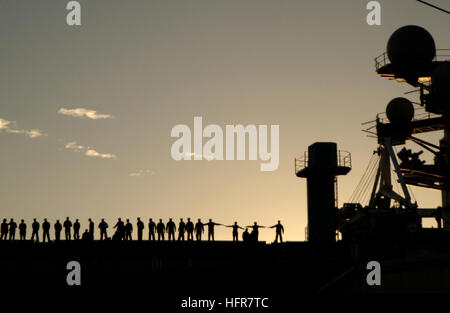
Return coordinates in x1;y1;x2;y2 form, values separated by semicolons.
296;25;450;244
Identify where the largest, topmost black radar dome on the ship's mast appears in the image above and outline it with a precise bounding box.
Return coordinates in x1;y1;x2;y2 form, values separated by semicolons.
387;25;436;64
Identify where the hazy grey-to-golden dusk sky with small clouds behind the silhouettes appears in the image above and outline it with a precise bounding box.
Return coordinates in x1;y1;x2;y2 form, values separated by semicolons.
0;0;450;241
